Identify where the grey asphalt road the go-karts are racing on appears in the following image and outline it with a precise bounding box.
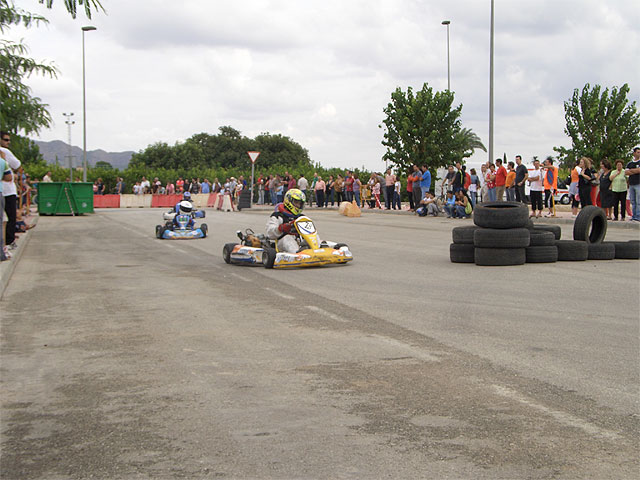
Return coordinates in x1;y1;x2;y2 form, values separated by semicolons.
0;209;640;479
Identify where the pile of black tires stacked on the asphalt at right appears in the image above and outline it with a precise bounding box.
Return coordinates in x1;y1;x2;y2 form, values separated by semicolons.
449;202;640;266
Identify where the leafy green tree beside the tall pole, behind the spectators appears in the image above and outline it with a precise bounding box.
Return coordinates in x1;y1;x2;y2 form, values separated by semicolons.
380;83;484;171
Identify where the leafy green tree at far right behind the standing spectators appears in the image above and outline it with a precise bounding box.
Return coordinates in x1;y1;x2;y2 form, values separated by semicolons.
554;83;640;167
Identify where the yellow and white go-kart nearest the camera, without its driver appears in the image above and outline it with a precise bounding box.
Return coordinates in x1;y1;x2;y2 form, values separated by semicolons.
222;215;353;268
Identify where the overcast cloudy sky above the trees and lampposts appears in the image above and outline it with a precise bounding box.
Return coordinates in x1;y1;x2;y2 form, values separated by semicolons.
6;0;640;170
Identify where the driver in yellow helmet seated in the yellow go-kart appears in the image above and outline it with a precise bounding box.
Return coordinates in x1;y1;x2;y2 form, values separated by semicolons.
267;188;307;253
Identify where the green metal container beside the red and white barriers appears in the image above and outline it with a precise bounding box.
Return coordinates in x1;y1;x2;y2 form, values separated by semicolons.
38;182;93;215
